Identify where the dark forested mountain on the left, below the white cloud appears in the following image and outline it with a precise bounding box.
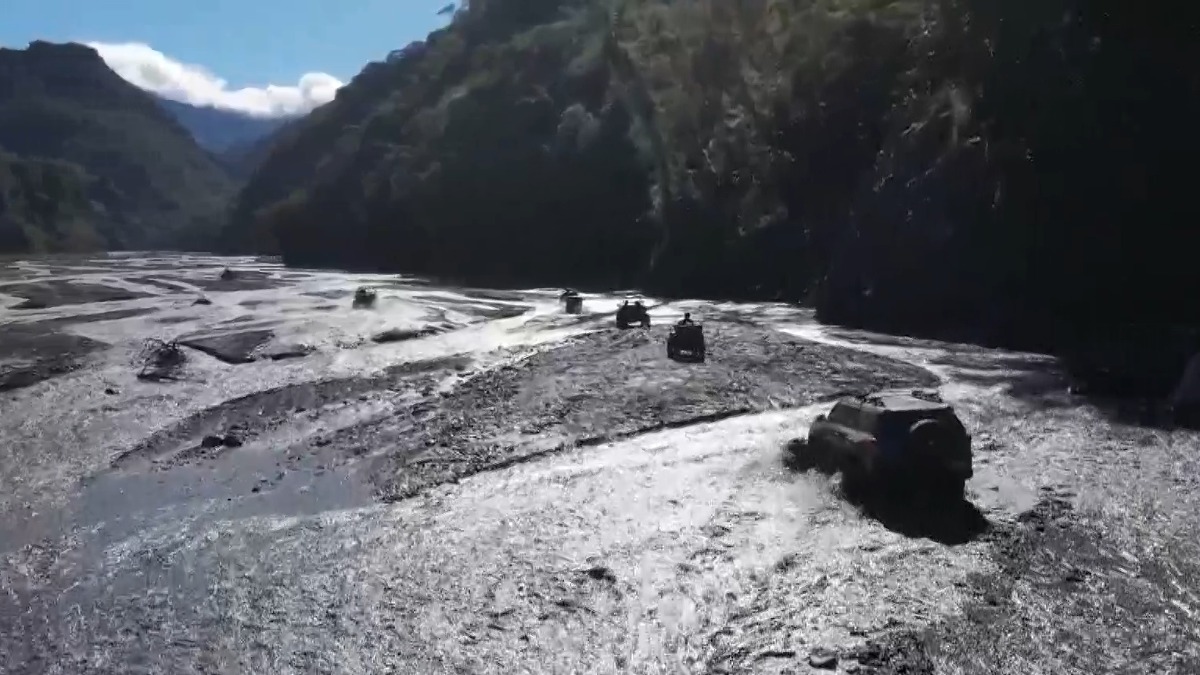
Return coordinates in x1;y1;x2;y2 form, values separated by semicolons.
0;42;234;250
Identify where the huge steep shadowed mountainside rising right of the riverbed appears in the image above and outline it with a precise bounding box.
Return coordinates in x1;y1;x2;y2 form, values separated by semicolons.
227;0;1200;367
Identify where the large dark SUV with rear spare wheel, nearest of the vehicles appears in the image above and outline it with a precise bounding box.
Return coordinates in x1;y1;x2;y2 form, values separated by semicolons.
787;392;974;503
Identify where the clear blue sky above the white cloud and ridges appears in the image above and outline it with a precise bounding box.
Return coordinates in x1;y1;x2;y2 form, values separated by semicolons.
0;0;449;114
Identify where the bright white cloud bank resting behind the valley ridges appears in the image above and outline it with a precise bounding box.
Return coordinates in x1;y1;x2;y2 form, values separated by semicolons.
88;42;342;118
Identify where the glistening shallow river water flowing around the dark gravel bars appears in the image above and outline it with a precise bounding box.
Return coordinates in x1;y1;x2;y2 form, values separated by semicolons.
0;256;1200;673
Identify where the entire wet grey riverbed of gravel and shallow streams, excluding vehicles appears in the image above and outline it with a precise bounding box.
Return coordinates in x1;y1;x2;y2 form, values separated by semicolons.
0;256;1200;674
